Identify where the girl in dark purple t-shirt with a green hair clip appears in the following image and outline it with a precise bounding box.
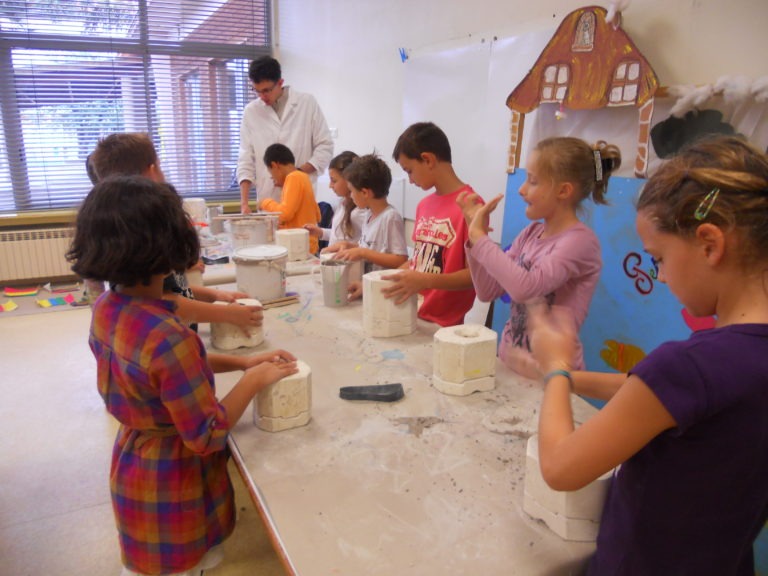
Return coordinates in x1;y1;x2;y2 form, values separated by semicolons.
531;136;768;576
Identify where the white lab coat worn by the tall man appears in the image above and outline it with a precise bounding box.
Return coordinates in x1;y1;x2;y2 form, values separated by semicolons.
237;89;333;202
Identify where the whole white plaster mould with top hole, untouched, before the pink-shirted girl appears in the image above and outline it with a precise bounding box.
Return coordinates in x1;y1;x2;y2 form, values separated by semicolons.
432;324;496;396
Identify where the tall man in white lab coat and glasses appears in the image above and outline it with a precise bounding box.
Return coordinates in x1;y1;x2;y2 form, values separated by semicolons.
237;56;333;214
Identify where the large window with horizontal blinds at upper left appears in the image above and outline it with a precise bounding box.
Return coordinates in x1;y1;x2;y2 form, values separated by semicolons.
0;0;271;212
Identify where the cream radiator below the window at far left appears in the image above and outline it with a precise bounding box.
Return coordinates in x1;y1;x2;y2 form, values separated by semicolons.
0;228;74;282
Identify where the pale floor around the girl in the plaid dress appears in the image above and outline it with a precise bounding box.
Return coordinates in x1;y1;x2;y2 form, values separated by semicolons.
0;308;285;576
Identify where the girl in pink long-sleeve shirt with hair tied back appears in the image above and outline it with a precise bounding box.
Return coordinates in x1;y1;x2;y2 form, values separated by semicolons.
457;137;621;378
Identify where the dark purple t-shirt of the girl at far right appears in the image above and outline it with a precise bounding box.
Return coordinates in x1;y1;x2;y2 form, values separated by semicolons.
588;324;768;576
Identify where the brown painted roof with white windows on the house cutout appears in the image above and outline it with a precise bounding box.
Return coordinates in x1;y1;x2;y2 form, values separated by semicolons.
507;6;659;114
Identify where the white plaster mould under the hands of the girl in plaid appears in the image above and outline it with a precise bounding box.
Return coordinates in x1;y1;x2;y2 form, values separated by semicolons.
253;360;312;432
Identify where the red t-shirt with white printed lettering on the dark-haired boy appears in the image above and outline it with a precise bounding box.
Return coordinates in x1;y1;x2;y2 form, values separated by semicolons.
410;185;475;326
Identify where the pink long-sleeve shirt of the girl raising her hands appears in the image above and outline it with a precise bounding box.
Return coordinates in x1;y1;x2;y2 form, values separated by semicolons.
467;222;603;378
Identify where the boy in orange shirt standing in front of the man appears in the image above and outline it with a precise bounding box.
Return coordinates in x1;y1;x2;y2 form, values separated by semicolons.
259;144;320;254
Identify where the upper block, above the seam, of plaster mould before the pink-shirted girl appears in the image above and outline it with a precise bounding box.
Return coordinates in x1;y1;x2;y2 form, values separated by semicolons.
433;324;496;384
